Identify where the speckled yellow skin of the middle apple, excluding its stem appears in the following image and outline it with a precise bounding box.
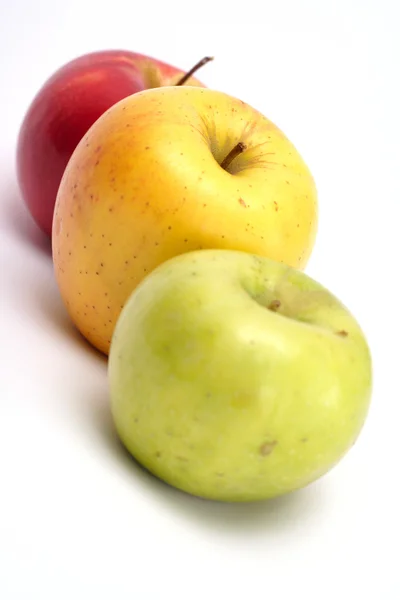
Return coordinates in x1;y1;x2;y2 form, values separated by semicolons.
53;86;317;354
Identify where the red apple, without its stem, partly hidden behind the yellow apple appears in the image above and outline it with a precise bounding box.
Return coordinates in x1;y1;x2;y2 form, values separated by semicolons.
17;50;203;237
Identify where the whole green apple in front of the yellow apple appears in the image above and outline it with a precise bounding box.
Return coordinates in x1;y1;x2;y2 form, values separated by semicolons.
109;250;372;502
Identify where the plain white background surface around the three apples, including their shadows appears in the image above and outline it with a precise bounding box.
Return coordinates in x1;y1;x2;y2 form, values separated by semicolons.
0;0;400;600
